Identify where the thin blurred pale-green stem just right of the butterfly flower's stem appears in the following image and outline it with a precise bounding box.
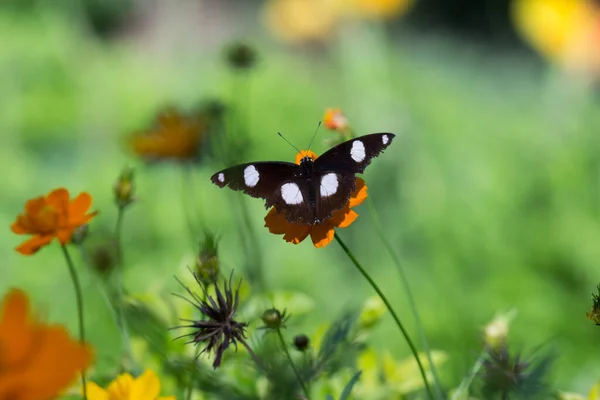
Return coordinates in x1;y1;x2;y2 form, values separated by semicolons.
367;197;444;399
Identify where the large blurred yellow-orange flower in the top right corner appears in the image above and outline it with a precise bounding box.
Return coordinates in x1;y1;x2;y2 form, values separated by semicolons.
512;0;600;72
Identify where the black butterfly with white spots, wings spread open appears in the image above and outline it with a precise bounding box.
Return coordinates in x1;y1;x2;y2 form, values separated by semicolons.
210;133;396;225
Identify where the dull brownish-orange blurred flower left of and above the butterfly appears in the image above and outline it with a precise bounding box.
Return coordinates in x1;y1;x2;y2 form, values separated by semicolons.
130;110;208;161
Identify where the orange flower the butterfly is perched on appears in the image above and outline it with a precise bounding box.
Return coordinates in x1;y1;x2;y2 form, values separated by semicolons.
265;150;367;247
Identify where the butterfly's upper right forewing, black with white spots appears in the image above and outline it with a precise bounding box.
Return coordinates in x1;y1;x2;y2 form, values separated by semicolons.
315;133;396;174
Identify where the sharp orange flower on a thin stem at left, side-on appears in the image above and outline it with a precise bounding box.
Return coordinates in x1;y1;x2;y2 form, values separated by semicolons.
10;188;97;255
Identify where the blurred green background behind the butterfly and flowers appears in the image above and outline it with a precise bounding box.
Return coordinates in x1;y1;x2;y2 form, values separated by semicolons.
0;0;600;392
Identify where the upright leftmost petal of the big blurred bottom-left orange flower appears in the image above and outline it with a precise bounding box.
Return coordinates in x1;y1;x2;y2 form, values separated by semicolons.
0;289;34;366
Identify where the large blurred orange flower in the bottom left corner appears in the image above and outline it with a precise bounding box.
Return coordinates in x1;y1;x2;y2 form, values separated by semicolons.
0;289;92;400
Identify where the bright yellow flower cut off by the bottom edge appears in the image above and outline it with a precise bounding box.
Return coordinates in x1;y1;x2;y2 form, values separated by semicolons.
87;370;175;400
